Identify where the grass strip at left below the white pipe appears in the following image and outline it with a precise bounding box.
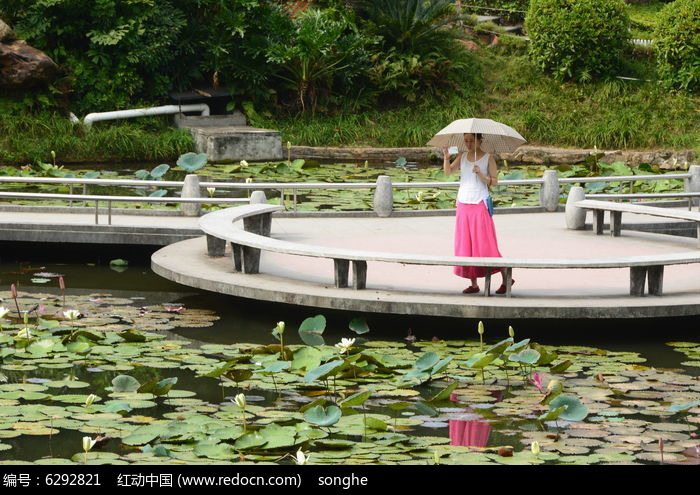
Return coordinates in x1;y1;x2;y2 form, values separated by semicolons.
0;112;192;165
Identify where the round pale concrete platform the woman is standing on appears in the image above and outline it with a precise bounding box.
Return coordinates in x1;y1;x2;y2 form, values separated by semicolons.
152;213;700;319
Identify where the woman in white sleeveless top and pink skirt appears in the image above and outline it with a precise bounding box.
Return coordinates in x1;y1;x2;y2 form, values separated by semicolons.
442;134;515;294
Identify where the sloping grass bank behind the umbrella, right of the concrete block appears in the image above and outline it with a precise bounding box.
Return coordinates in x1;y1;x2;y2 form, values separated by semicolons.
254;50;700;154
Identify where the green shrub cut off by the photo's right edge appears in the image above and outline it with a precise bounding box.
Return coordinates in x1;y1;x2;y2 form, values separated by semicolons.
654;0;700;91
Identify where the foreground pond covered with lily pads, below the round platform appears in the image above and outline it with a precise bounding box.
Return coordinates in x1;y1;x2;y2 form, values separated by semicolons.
0;245;700;464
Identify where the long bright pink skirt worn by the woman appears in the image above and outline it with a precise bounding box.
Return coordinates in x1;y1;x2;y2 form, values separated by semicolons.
454;201;502;278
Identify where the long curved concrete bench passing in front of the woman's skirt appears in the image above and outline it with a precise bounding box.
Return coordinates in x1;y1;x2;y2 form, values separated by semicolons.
199;204;700;297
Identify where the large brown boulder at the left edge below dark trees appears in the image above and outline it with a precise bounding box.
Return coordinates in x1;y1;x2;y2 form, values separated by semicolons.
0;40;58;89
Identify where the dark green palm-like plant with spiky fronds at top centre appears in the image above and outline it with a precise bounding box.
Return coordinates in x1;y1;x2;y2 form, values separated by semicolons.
358;0;465;54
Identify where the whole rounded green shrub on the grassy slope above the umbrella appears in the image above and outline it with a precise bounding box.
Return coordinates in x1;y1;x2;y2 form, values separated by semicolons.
525;0;629;82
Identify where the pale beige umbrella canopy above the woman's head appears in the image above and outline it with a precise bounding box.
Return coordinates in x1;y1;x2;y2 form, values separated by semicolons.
428;119;527;153
